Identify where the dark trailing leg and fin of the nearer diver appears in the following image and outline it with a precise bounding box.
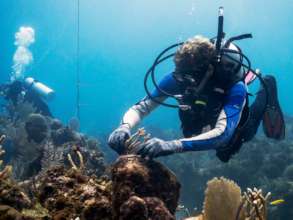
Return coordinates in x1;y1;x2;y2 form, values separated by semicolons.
217;76;285;162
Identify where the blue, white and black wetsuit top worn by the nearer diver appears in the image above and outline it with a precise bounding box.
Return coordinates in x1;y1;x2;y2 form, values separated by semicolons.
123;74;247;156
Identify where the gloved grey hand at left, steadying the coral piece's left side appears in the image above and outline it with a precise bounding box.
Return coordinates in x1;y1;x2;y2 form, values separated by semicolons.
108;124;130;154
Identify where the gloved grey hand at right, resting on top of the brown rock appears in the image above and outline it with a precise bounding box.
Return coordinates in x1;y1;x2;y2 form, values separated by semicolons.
136;138;182;158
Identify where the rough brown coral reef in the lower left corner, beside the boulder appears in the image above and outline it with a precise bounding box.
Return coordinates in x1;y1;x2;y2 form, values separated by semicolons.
0;130;111;220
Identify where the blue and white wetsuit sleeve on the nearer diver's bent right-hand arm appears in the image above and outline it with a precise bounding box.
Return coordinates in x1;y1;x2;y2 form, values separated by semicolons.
180;82;247;151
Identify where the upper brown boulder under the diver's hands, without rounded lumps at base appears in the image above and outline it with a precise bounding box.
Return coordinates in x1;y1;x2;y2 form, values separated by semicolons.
112;155;180;217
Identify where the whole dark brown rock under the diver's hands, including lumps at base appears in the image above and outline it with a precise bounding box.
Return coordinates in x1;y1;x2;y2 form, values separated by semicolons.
112;155;180;219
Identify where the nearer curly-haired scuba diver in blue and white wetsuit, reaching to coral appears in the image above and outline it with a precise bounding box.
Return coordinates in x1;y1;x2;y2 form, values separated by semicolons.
108;8;285;162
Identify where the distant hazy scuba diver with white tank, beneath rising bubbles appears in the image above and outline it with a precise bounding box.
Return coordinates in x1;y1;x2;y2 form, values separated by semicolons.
0;77;54;117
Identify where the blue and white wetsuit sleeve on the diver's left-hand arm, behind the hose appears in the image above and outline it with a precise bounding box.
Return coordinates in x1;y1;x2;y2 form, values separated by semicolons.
122;73;179;128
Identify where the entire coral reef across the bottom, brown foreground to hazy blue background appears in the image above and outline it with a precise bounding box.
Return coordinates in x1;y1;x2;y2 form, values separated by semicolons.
0;90;293;220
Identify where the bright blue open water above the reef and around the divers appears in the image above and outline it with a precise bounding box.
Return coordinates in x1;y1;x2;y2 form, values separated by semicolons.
0;0;293;137
